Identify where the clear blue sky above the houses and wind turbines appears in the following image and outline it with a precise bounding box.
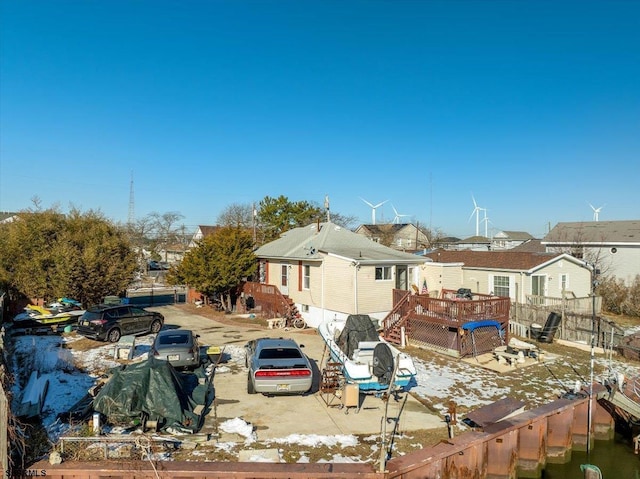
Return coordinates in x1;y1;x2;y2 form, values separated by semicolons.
0;0;640;237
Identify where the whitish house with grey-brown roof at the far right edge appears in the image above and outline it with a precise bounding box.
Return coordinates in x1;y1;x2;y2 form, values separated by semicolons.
542;220;640;285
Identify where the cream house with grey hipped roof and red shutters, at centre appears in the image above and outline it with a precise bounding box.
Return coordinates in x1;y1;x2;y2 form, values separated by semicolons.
255;222;425;327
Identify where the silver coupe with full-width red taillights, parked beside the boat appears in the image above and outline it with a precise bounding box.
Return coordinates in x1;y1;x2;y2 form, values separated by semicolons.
245;338;313;395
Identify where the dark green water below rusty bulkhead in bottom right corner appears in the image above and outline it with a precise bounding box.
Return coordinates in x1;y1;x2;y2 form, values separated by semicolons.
542;434;640;479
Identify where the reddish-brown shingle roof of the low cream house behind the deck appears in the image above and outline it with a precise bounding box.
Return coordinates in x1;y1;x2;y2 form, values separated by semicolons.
426;250;580;271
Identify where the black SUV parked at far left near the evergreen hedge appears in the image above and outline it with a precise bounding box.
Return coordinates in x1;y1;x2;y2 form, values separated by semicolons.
78;304;164;343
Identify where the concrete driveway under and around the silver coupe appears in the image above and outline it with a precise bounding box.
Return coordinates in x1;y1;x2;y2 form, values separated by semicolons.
154;306;445;442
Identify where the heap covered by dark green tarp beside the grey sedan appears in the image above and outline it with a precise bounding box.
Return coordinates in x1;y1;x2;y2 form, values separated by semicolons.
93;356;213;432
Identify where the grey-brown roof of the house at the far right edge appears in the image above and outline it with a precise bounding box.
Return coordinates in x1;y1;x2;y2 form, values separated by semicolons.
542;220;640;245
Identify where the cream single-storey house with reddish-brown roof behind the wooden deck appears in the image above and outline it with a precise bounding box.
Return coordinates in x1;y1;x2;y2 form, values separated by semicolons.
424;250;591;303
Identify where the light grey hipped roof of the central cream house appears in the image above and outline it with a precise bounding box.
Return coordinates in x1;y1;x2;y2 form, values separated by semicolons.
255;223;425;264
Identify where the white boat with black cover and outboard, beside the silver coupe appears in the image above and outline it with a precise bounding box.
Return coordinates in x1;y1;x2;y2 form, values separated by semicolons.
318;314;416;394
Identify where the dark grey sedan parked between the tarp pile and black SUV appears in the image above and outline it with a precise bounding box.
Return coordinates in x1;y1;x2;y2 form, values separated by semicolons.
151;329;200;368
